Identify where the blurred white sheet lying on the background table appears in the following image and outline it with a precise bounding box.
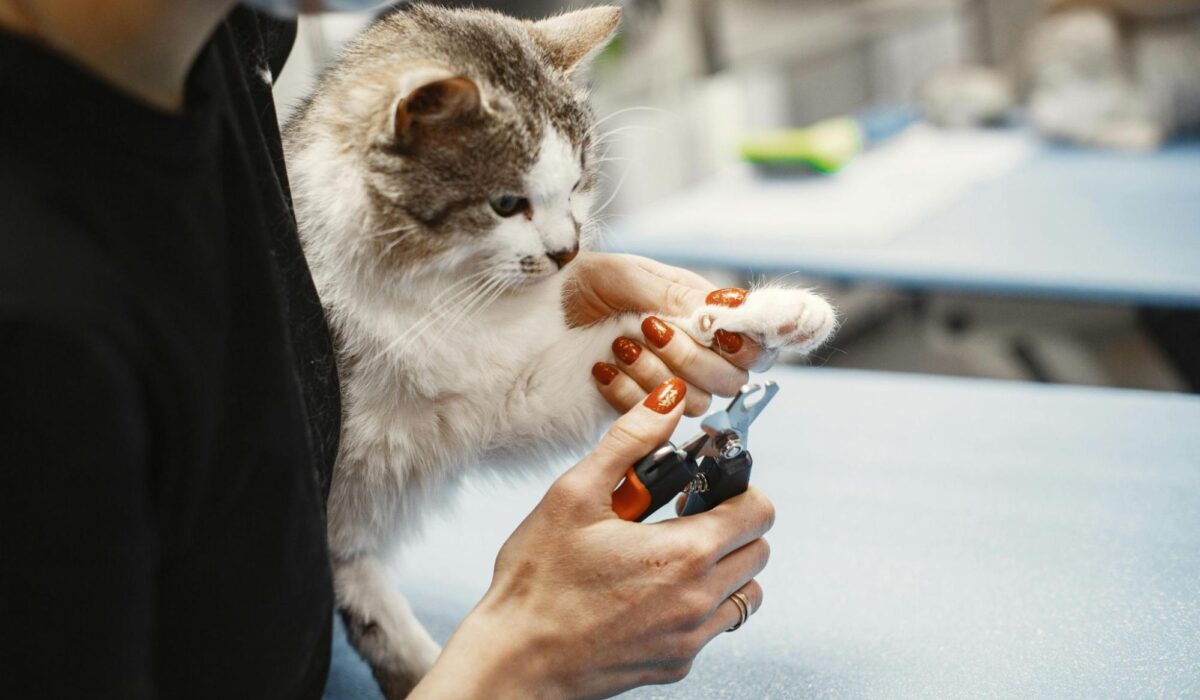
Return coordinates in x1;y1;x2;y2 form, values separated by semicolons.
624;124;1037;243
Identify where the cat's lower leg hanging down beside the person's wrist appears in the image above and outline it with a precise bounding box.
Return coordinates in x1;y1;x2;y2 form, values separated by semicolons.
334;555;442;700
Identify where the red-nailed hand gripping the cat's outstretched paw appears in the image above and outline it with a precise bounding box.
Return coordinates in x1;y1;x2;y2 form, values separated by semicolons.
563;253;763;415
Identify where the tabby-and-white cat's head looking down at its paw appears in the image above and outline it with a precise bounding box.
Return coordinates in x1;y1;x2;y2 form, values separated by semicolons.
289;6;620;288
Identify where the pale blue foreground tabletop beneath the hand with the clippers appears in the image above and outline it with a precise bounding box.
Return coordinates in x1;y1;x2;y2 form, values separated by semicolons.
328;367;1200;700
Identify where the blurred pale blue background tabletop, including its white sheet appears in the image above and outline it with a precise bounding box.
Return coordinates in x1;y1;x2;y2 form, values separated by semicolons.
608;129;1200;309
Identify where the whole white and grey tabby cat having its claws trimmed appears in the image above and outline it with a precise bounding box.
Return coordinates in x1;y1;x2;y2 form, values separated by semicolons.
284;6;835;698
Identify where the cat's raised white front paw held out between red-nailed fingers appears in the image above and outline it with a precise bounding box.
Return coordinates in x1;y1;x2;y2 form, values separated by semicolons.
688;287;838;354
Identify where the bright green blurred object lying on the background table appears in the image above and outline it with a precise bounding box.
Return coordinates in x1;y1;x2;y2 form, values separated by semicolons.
742;116;866;173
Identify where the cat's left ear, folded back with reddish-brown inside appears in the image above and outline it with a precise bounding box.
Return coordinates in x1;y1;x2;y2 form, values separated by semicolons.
392;70;481;143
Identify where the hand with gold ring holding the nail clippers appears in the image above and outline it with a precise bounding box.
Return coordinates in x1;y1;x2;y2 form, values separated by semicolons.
410;379;774;698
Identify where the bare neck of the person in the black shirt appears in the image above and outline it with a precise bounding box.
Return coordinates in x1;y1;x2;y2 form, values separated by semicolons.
0;0;234;112
